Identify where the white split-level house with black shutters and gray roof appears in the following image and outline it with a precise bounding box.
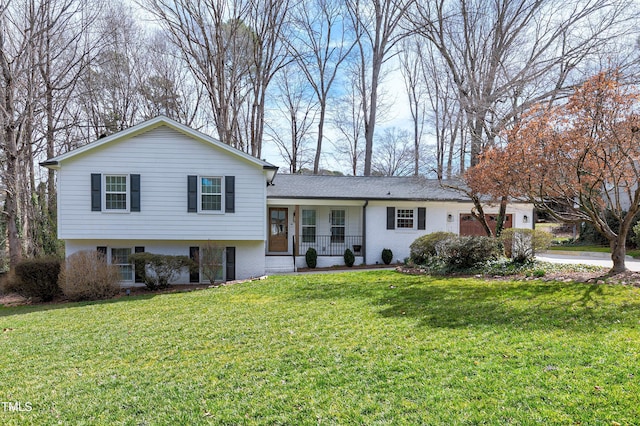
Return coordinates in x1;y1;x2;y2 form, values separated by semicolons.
42;117;533;285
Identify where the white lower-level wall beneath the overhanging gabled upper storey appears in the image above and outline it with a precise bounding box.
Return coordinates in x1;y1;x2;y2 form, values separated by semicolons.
65;239;265;284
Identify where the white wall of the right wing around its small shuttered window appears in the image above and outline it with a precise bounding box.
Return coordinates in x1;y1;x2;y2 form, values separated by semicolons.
366;201;533;264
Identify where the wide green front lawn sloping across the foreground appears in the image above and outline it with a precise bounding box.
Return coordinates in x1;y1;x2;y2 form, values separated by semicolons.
0;271;640;425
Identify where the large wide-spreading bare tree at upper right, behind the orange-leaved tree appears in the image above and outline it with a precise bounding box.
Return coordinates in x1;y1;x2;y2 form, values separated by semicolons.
411;0;637;165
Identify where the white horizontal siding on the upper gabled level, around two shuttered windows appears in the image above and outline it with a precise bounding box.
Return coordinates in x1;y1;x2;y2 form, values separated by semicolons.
58;126;266;241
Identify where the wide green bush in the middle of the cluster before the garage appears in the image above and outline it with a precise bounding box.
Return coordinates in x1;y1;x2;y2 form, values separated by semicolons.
436;236;500;271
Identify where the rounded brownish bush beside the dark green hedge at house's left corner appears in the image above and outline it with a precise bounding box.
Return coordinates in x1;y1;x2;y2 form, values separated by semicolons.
58;250;120;301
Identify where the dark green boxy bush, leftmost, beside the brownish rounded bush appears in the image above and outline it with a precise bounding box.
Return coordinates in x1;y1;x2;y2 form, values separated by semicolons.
12;258;60;302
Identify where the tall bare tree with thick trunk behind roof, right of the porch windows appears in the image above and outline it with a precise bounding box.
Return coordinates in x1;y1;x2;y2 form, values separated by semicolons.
347;0;414;176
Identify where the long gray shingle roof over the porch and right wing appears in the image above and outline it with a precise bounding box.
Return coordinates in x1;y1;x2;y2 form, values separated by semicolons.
267;174;470;201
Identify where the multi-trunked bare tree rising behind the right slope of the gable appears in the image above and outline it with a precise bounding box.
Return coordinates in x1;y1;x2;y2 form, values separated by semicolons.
144;0;288;157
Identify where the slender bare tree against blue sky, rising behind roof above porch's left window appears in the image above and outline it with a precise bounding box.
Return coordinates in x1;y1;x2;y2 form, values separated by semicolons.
289;0;355;174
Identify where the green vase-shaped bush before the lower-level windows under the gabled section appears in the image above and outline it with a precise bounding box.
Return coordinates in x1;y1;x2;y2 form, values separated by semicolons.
129;253;193;290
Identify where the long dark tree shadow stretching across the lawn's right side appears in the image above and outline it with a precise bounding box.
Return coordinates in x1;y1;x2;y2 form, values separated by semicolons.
290;274;640;331
